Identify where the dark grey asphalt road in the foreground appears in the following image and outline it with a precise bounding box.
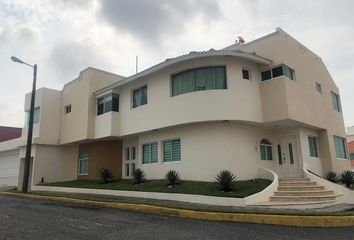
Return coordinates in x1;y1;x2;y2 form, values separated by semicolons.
0;195;354;240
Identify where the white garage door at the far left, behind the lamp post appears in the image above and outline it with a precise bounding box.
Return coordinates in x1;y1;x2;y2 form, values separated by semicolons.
0;149;19;187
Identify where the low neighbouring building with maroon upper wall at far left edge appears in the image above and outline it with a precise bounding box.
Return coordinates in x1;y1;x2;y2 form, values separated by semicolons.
0;126;21;187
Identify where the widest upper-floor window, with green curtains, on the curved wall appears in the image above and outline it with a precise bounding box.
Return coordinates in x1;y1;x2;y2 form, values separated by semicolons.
172;66;226;96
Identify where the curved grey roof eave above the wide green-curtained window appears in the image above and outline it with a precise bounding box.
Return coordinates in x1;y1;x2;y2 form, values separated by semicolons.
94;49;272;95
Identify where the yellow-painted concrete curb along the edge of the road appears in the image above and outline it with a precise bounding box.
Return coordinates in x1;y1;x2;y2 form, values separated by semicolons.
0;192;354;227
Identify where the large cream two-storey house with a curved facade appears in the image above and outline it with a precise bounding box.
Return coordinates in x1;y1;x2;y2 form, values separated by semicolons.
9;29;350;189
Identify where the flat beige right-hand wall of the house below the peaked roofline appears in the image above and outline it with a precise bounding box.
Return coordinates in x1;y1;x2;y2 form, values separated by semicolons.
236;29;350;175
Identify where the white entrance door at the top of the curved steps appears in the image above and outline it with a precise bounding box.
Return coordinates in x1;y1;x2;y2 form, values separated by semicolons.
277;136;302;177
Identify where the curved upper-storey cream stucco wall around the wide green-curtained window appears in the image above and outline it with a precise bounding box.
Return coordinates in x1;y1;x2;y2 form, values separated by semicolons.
110;57;262;136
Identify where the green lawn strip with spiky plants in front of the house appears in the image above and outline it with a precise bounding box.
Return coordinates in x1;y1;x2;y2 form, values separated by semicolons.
46;179;271;198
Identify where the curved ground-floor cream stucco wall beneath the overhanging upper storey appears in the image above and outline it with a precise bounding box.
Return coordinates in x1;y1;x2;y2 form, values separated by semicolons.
127;122;275;181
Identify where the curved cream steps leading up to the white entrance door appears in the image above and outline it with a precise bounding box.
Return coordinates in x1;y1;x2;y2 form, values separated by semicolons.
267;178;337;206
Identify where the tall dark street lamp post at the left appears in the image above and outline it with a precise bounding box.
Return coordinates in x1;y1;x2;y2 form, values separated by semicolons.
11;56;37;192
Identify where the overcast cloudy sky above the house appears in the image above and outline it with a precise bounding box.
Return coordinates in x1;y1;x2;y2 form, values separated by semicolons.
0;0;354;127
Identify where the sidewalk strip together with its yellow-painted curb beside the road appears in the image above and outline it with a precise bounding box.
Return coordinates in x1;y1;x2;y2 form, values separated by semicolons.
0;191;354;227
